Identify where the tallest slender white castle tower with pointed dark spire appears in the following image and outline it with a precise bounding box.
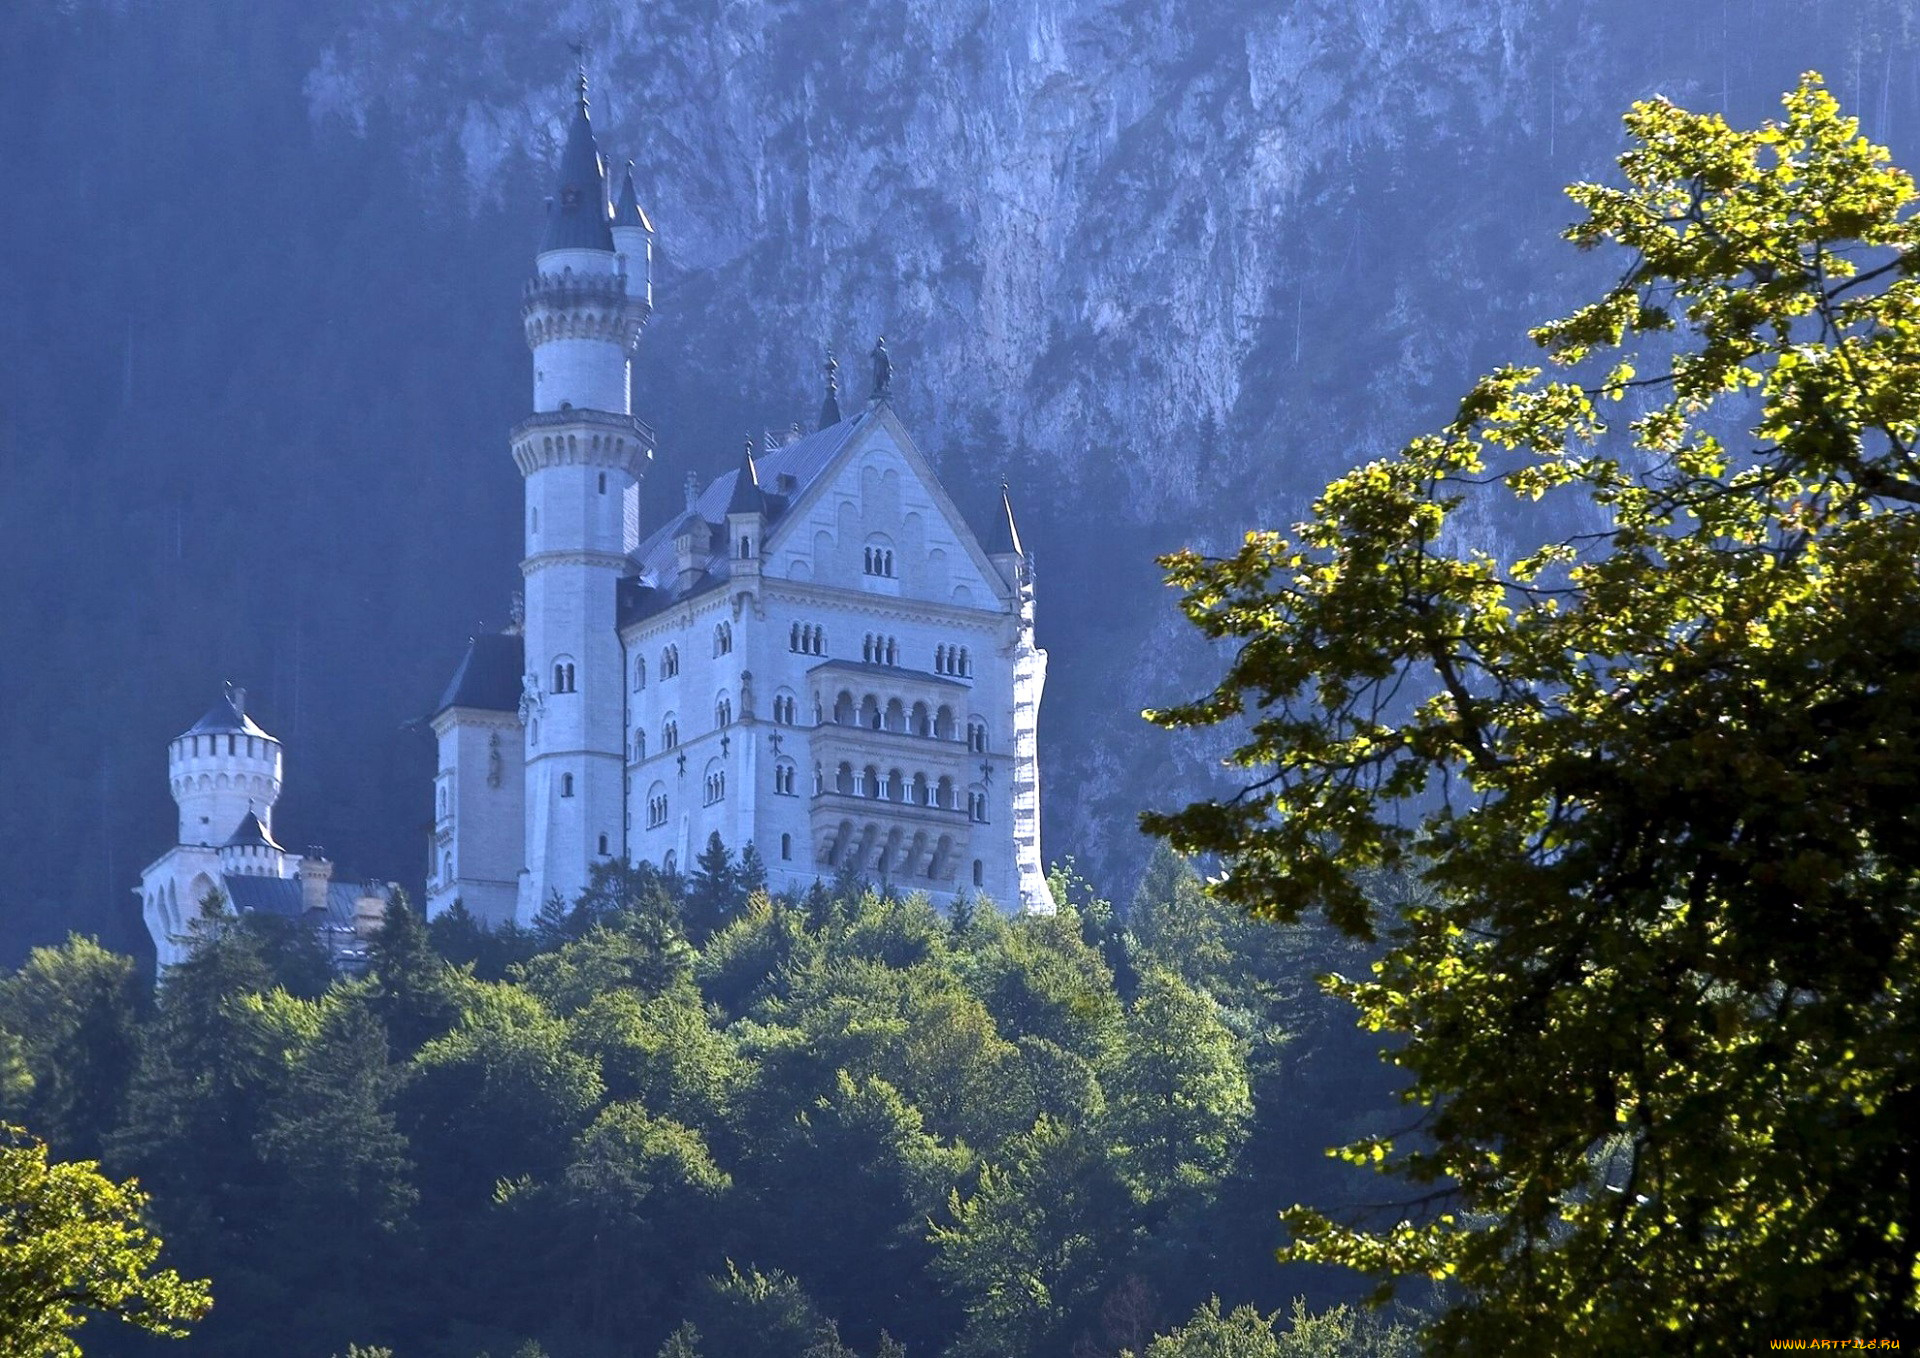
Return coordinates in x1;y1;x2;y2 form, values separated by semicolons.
513;73;653;920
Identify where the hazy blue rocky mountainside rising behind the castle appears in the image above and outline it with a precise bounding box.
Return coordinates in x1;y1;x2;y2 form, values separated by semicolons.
0;0;1920;956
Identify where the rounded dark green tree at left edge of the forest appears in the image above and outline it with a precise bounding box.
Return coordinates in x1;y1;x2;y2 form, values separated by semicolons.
0;934;142;1156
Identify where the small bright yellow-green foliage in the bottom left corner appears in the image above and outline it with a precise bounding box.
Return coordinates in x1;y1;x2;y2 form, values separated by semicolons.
0;1124;211;1358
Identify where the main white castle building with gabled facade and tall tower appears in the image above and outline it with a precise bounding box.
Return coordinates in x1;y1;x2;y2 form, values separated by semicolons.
426;77;1052;924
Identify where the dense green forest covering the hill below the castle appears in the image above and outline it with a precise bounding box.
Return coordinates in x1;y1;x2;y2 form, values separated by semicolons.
0;856;1411;1358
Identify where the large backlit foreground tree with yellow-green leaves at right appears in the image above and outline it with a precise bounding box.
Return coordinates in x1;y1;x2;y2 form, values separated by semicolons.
1146;77;1920;1356
